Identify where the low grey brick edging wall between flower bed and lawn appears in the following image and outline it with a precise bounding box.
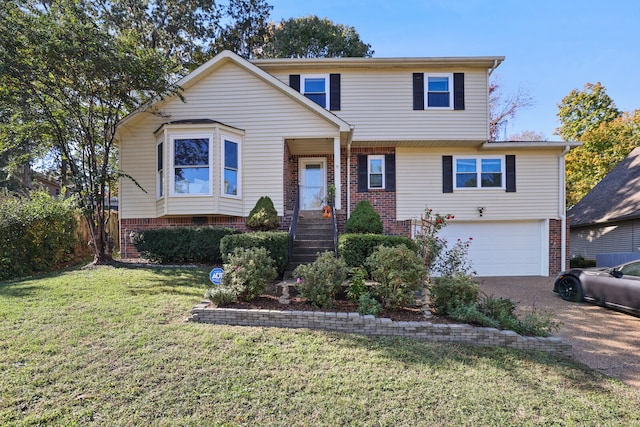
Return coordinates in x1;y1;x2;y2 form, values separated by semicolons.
189;301;571;356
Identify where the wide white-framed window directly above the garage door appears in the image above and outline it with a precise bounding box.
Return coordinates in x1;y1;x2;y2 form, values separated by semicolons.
455;157;505;188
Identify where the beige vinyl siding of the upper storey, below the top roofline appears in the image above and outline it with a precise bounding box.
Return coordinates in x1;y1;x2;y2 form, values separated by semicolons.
268;68;489;141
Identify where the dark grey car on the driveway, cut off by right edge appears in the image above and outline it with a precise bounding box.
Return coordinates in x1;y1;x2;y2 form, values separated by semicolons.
553;260;640;315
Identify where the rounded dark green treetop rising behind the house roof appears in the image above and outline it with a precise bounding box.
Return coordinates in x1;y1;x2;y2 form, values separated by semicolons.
264;16;374;58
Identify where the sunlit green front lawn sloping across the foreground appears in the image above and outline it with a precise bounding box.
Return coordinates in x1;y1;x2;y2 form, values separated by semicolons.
0;267;640;426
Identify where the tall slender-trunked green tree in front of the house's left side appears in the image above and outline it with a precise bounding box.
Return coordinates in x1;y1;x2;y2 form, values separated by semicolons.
0;0;177;263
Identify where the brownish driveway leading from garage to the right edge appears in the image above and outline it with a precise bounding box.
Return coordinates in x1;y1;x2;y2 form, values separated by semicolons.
478;277;640;389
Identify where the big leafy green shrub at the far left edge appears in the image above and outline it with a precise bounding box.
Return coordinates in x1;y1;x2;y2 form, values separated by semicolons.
0;191;76;280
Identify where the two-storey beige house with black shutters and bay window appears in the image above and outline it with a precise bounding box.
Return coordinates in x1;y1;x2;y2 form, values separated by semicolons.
117;51;575;276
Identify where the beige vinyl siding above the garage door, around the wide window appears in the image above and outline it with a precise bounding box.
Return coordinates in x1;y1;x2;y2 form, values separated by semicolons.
396;147;559;221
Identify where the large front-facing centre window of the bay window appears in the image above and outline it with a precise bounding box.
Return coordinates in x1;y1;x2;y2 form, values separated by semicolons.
171;135;213;195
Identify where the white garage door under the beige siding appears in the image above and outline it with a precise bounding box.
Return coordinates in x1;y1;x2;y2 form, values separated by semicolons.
438;221;549;276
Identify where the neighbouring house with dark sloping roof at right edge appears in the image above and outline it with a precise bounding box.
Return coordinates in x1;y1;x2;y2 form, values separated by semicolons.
568;148;640;259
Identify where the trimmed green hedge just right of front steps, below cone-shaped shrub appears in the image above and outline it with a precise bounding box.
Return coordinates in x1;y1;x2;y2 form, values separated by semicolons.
338;234;418;267
